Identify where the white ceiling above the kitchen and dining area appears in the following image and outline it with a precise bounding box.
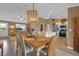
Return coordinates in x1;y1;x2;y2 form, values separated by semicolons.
0;3;79;20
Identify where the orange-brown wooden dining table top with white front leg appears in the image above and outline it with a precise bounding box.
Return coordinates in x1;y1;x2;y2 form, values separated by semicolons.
25;37;49;56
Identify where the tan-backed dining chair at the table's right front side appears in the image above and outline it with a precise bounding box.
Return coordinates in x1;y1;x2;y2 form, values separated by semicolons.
40;36;57;56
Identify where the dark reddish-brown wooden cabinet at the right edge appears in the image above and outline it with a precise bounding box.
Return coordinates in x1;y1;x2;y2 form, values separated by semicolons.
73;17;79;53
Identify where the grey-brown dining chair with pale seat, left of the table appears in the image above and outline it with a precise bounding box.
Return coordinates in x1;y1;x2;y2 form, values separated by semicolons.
17;33;33;56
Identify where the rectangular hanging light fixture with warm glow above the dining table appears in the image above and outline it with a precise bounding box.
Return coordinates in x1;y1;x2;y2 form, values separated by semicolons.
27;3;38;23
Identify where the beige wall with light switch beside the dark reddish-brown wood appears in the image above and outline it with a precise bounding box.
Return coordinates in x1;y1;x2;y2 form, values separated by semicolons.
67;6;79;48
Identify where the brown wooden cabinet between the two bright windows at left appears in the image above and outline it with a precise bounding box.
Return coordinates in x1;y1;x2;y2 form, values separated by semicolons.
8;22;16;37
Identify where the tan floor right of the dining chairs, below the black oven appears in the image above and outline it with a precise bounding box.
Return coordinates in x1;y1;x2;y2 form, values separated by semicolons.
55;37;79;56
